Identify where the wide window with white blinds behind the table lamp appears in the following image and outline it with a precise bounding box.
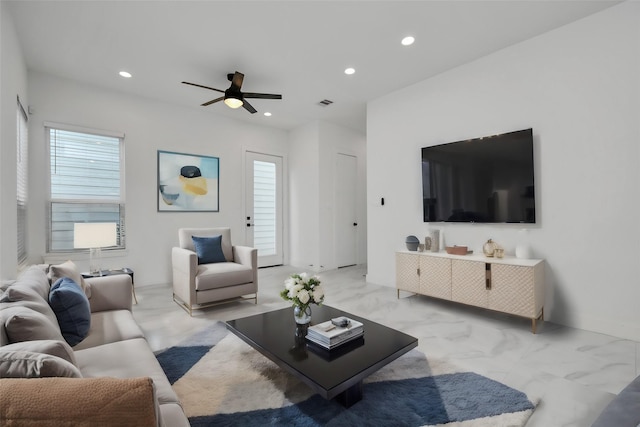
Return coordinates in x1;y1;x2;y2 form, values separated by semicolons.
45;125;125;252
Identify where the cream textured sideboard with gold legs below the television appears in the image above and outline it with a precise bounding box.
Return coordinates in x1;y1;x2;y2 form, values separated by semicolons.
396;251;544;334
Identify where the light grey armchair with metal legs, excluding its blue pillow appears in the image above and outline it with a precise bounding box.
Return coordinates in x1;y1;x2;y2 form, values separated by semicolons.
171;228;258;315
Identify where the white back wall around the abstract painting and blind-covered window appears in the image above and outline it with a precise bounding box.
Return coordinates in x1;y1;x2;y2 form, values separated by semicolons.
26;73;288;285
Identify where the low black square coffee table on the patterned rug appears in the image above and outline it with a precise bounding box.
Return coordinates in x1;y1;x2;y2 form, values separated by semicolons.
227;305;418;407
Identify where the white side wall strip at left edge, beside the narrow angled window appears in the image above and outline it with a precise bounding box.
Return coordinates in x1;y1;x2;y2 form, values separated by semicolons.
0;2;28;279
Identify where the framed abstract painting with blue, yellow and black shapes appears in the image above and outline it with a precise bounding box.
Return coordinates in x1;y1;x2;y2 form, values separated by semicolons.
157;150;220;212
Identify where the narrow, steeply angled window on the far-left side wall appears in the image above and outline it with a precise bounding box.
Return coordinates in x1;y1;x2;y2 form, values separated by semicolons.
16;97;29;266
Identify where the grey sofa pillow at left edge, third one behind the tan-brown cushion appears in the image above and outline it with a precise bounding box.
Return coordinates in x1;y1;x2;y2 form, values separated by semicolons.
0;306;64;343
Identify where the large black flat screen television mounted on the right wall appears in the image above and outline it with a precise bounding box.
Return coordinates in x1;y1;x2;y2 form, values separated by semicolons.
422;129;536;224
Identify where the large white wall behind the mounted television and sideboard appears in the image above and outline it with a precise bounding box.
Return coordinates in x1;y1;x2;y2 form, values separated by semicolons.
367;2;640;340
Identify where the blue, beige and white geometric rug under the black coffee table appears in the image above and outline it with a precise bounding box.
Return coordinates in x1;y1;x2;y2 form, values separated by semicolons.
156;322;537;427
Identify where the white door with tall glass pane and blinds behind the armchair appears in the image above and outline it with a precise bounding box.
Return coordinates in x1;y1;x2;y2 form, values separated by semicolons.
245;151;284;267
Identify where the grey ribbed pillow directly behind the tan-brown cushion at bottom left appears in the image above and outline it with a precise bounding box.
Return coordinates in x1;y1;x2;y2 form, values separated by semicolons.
0;348;82;378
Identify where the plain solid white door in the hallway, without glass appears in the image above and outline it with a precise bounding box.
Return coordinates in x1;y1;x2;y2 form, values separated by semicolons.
334;153;358;268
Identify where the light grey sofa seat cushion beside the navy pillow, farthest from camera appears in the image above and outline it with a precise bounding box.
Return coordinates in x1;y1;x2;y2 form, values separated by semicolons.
73;310;144;351
